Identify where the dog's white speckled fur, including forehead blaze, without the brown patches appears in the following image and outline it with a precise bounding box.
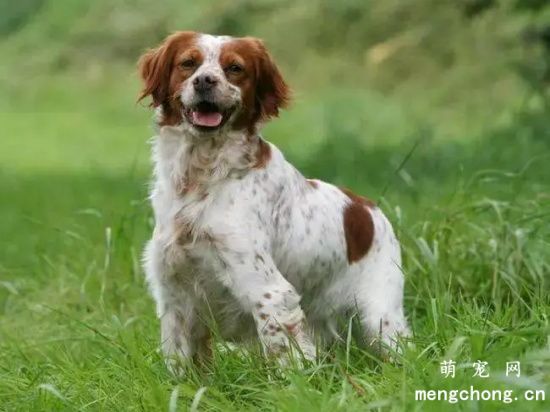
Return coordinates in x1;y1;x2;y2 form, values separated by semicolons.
144;36;408;370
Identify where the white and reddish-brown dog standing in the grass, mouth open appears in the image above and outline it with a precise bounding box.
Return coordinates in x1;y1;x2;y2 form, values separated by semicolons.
139;32;408;368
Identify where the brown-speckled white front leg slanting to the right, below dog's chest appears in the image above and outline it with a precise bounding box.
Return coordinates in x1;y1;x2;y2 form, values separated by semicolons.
219;252;315;363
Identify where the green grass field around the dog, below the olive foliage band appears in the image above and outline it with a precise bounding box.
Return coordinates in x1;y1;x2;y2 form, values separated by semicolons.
0;1;550;412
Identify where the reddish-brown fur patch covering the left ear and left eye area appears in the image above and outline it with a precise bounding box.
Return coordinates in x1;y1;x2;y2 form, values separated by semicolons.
138;31;203;126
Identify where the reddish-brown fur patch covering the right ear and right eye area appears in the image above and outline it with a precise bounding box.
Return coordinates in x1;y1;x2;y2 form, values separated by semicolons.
220;37;290;134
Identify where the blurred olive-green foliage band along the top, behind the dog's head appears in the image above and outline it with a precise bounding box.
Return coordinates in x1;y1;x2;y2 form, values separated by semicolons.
0;0;550;134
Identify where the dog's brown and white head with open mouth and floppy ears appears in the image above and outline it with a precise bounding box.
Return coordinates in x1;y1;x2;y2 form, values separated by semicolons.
139;32;290;136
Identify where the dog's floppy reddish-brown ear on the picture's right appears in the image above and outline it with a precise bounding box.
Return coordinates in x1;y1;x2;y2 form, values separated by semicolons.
253;39;291;119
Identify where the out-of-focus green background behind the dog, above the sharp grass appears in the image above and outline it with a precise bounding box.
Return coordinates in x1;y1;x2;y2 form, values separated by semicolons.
0;0;550;268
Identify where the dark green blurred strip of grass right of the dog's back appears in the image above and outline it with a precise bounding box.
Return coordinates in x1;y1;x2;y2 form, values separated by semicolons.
301;103;550;201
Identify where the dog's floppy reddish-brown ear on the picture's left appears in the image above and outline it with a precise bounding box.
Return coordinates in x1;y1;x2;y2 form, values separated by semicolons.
138;43;171;107
